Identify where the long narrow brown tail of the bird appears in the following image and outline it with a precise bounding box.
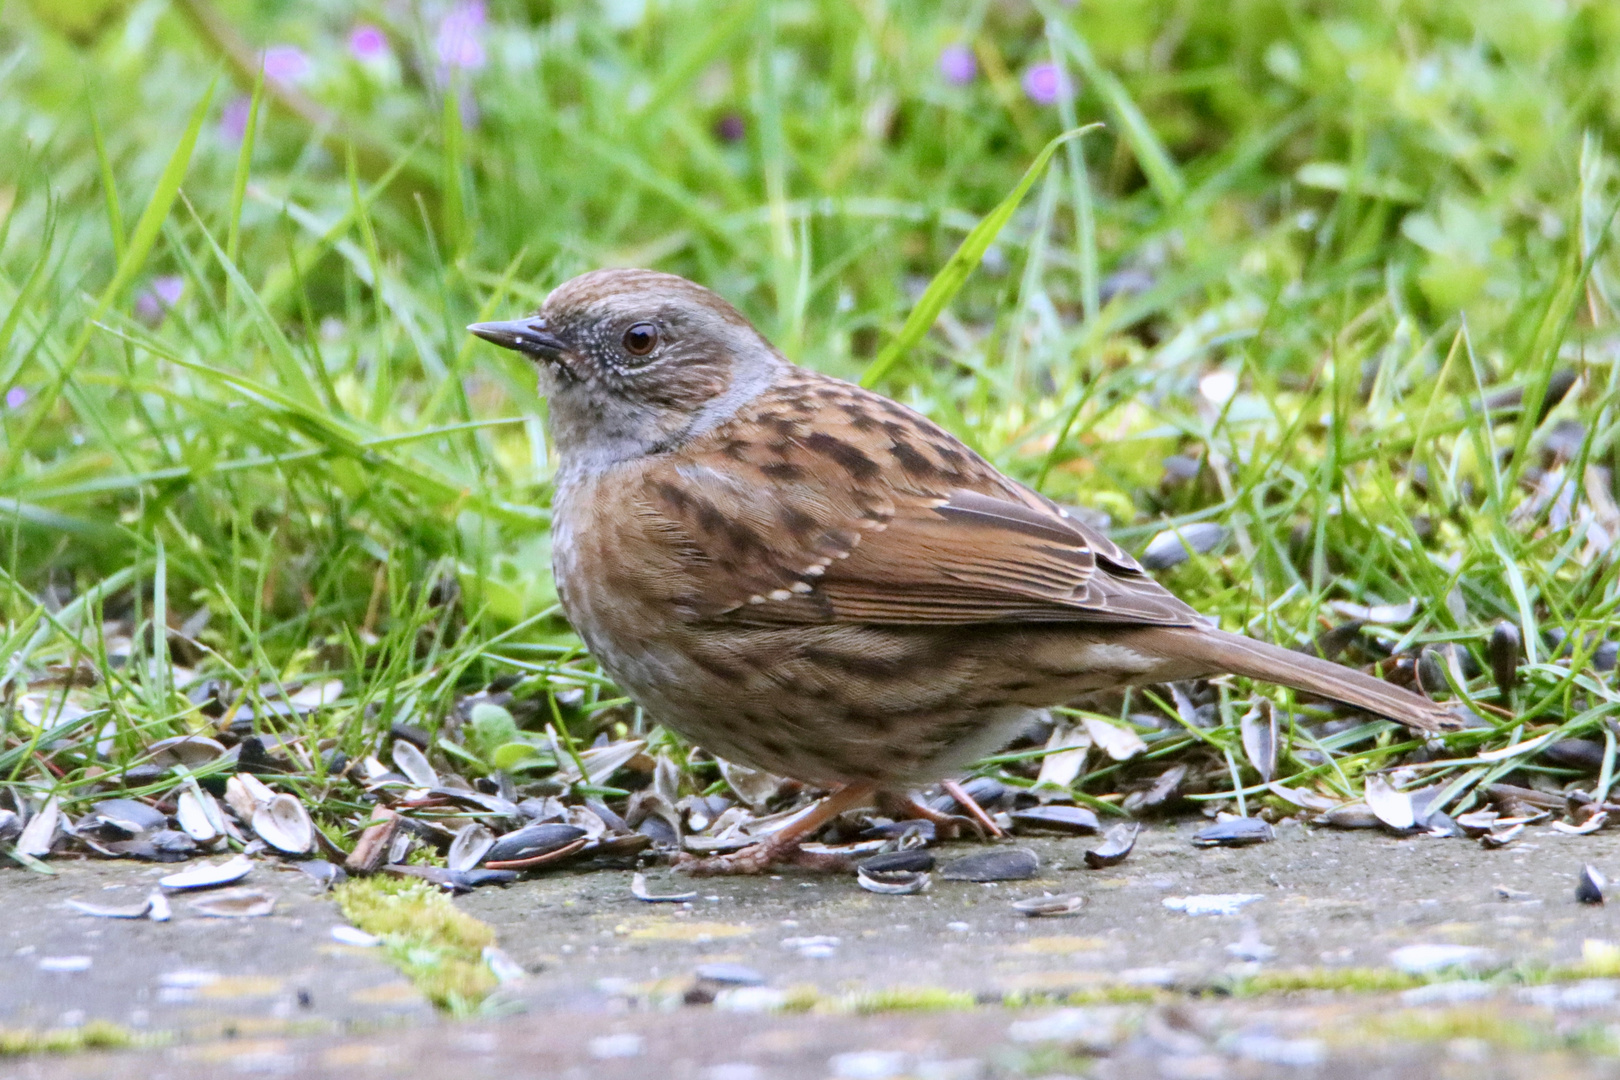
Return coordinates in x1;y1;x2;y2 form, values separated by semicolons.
1176;628;1463;732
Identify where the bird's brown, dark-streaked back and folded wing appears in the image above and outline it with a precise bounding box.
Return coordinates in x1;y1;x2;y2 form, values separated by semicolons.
637;372;1197;625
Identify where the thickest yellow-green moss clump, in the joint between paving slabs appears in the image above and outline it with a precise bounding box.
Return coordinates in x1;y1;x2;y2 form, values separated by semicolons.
335;878;497;1015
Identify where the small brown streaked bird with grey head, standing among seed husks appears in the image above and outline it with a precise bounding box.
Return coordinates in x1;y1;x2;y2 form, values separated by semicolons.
468;270;1458;873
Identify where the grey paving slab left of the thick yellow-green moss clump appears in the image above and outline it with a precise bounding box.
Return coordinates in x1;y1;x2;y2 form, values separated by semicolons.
0;860;434;1040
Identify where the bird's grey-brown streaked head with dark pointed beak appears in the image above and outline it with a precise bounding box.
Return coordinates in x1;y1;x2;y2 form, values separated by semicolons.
467;270;787;470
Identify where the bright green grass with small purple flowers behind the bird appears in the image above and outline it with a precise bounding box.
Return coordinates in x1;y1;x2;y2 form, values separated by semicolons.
0;0;1620;823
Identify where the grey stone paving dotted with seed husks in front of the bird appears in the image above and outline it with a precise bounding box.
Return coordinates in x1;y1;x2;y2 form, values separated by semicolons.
9;824;1620;1080
